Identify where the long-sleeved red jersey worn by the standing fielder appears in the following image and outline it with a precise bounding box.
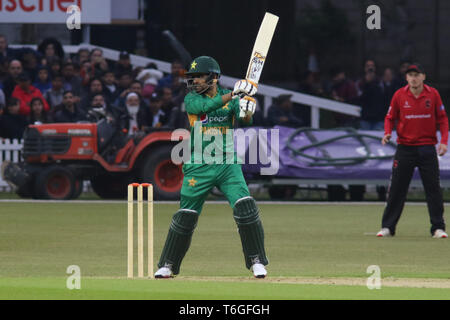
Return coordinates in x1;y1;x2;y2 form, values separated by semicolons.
384;85;448;146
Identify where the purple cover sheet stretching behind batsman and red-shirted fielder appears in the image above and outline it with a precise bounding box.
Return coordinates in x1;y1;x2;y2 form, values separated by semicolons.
242;127;450;180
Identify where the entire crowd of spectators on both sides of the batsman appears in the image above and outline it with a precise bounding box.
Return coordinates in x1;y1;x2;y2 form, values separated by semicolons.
0;35;409;139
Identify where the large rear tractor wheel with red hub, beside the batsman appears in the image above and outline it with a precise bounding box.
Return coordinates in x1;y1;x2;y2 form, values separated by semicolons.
141;145;183;200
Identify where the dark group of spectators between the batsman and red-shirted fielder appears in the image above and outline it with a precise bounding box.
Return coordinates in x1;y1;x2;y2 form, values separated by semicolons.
265;59;410;130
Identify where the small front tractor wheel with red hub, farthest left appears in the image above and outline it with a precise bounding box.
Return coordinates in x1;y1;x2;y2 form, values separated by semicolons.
34;166;75;200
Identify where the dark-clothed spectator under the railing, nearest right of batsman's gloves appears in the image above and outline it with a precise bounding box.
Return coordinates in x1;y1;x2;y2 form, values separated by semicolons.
267;94;303;128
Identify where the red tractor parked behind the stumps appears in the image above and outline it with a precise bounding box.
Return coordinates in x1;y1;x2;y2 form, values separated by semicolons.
2;115;183;200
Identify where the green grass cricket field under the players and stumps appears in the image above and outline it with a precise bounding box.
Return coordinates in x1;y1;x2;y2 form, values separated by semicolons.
0;202;450;300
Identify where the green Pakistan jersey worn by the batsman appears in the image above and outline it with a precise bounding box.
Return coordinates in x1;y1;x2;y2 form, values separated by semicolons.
184;85;251;164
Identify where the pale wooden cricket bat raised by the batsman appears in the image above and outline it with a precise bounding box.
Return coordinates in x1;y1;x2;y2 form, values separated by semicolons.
240;12;278;118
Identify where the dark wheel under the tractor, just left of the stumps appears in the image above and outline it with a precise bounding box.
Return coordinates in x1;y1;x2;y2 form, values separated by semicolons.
91;174;132;199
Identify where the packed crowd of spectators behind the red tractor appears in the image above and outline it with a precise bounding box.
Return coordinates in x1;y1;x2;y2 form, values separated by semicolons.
0;35;187;139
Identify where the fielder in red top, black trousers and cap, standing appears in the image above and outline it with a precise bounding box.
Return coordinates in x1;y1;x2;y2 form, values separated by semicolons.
377;63;449;238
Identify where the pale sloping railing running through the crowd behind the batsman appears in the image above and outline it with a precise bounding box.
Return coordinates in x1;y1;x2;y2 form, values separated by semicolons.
10;43;361;128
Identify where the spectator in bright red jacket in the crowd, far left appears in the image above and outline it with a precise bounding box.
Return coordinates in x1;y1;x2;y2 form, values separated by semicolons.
11;72;50;116
